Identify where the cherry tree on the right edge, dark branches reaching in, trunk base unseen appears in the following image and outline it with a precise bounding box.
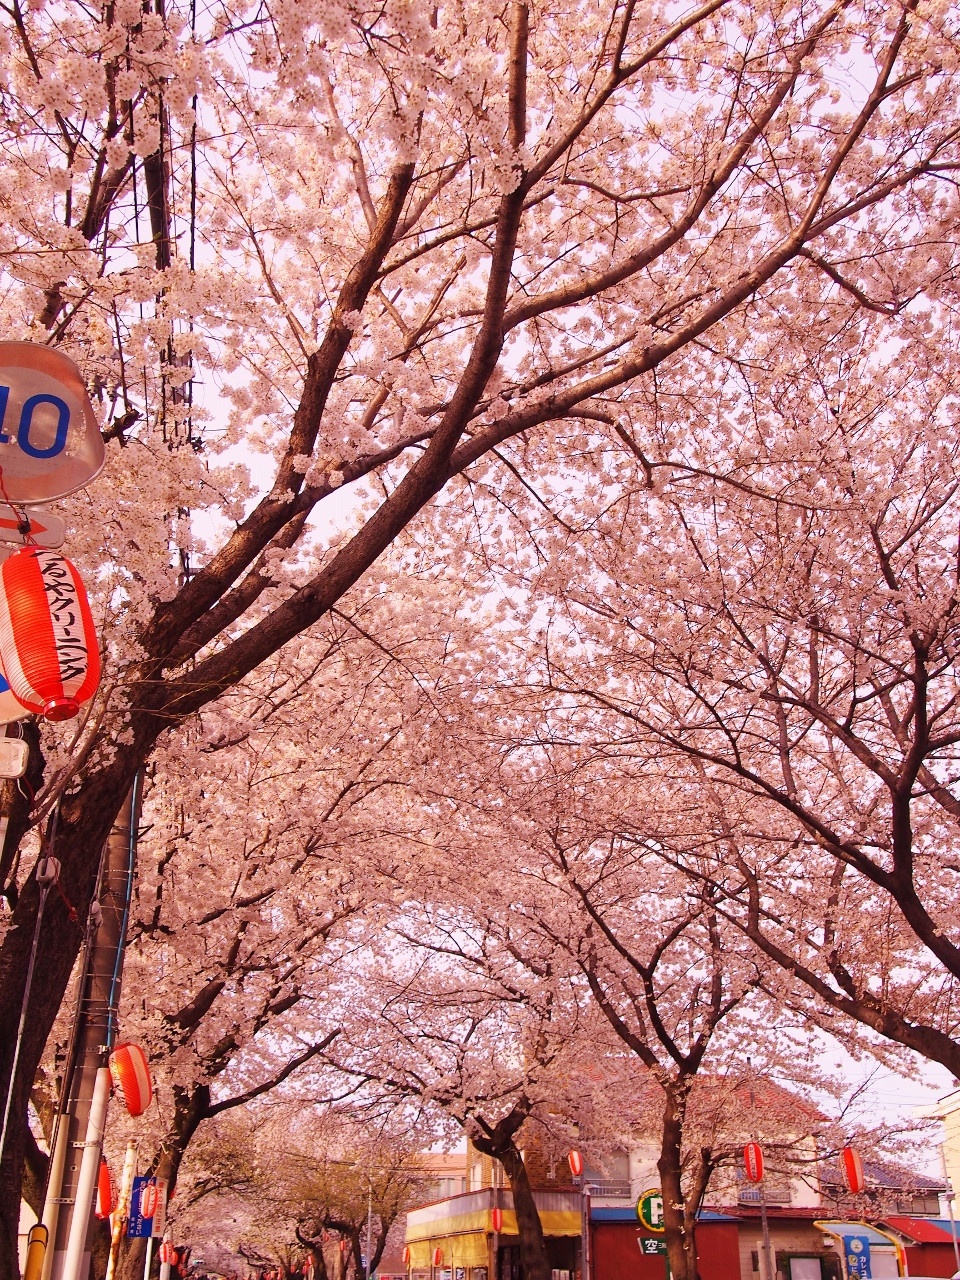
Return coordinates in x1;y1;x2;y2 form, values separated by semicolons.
556;350;960;1071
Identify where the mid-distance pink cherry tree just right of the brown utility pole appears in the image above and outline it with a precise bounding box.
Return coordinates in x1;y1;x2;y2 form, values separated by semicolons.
103;611;471;1275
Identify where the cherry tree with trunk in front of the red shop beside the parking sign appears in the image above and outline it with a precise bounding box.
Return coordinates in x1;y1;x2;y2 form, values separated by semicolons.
378;737;832;1280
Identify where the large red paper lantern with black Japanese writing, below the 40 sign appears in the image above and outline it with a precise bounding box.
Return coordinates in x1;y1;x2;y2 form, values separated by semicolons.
0;547;100;721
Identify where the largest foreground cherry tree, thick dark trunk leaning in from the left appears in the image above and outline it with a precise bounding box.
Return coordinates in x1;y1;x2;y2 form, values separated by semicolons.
0;0;957;1280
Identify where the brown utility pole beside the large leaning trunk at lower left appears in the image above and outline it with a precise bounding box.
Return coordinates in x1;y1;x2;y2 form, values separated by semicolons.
42;774;141;1280
